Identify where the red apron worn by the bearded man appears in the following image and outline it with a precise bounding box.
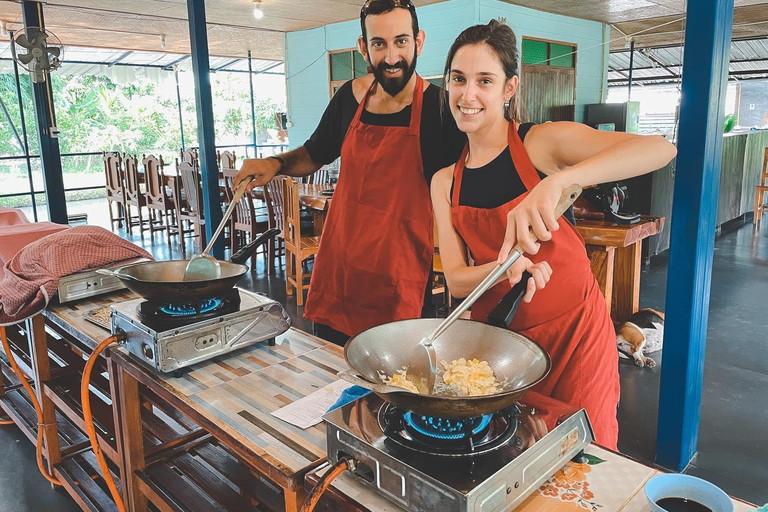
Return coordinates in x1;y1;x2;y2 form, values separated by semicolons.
304;76;434;336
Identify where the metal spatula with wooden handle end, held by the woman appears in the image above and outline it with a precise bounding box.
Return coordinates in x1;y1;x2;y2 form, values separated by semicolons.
407;183;581;395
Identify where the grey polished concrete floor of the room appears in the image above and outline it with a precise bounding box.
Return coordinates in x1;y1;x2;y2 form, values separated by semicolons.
0;203;768;512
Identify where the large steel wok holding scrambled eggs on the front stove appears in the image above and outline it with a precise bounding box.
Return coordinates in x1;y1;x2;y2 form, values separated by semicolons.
340;318;552;418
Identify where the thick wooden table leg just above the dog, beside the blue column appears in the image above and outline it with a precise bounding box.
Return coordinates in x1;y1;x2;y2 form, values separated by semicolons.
611;241;643;322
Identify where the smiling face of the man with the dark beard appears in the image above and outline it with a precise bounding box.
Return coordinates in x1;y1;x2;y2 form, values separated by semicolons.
359;9;424;96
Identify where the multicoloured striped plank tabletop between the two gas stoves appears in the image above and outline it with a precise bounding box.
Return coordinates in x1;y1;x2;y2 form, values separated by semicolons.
112;329;346;490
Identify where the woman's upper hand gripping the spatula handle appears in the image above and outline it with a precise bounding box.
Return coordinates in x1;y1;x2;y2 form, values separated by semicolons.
498;174;567;263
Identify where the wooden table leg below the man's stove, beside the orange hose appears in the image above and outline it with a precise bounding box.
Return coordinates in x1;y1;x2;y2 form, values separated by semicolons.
110;365;147;512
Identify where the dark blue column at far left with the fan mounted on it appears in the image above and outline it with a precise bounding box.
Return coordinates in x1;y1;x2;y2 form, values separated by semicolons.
21;1;69;224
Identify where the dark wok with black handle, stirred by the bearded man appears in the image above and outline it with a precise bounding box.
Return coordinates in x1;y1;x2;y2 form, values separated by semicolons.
99;229;279;303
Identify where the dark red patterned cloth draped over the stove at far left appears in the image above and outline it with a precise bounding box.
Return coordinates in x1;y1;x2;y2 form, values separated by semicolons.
0;226;153;325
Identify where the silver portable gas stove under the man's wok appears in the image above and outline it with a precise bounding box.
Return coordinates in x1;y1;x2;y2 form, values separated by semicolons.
110;288;291;372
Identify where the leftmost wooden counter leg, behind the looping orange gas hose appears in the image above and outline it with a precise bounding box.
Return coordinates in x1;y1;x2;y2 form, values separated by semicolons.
27;315;61;484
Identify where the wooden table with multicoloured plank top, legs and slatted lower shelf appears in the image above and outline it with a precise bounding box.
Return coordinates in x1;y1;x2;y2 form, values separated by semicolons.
110;320;346;511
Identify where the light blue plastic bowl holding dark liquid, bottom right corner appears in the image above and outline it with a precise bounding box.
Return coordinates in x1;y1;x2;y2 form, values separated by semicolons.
645;473;734;512
